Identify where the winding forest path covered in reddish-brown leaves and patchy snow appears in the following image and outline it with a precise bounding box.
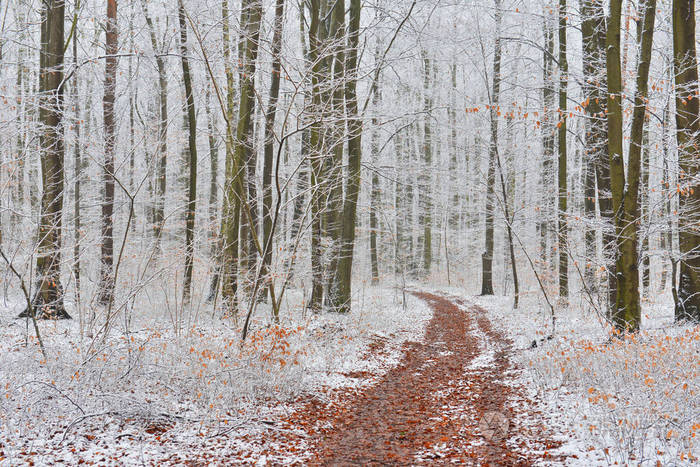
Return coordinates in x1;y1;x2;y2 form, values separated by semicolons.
294;292;561;466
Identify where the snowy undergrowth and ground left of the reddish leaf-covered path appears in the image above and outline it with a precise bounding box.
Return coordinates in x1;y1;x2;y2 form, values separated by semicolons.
0;288;431;465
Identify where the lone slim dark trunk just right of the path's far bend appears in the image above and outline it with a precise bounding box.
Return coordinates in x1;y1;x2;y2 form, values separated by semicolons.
481;0;503;295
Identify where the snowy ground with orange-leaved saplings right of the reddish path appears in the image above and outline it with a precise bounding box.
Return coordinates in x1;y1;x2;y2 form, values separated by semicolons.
475;295;700;466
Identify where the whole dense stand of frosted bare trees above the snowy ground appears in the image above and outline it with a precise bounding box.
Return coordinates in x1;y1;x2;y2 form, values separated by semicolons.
0;0;700;333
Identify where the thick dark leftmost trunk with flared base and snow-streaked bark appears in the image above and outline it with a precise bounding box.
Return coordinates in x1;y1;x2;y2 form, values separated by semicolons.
20;0;70;318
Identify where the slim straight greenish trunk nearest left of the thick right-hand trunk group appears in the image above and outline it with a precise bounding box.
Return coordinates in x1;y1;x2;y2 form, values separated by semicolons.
557;0;569;298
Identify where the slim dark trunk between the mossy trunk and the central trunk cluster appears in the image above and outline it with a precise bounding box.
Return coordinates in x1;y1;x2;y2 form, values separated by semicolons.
262;0;284;308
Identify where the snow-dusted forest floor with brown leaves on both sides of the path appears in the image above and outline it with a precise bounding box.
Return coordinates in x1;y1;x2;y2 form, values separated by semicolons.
0;287;700;465
